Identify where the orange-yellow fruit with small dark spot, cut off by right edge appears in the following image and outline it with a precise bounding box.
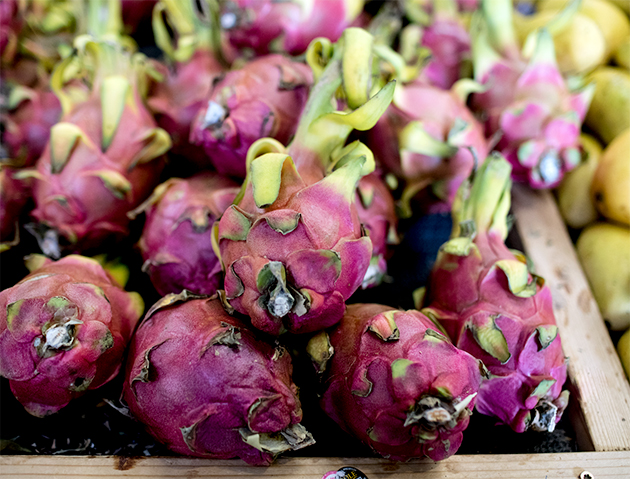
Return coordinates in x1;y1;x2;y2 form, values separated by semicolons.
591;128;630;227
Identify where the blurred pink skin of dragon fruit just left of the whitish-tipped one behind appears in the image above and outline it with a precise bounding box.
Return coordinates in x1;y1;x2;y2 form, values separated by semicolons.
147;49;223;164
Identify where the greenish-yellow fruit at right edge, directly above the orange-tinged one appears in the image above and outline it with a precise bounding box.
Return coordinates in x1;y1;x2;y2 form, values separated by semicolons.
584;66;630;144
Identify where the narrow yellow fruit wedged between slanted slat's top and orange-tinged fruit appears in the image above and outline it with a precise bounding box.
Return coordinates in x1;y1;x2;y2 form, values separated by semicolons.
556;134;602;229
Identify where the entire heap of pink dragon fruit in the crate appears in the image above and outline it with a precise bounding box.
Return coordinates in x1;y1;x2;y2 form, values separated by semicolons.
0;0;592;464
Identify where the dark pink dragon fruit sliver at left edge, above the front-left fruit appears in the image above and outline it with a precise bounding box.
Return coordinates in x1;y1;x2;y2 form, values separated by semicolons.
0;165;31;253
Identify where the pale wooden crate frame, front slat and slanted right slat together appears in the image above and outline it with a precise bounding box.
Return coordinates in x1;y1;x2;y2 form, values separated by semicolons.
0;185;630;479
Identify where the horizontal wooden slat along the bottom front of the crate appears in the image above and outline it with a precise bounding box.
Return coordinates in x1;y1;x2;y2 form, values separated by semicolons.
0;452;630;479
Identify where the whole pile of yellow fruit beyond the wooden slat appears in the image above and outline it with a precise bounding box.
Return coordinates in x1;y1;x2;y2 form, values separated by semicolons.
548;0;630;377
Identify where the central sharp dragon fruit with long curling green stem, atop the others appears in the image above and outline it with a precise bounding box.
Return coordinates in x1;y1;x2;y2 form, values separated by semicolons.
214;28;394;335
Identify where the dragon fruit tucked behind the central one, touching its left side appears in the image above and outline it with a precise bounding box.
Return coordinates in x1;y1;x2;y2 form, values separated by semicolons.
132;172;239;296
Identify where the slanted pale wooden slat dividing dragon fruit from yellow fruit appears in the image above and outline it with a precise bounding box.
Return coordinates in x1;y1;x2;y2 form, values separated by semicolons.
512;185;630;454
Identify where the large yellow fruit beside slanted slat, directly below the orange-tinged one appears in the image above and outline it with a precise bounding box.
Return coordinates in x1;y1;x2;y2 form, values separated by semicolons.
576;222;630;331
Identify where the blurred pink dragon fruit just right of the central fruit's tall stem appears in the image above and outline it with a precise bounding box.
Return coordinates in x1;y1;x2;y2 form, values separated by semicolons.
369;80;488;216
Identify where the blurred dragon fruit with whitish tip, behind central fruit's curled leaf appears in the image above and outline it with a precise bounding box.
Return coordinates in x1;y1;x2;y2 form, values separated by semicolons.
190;55;312;178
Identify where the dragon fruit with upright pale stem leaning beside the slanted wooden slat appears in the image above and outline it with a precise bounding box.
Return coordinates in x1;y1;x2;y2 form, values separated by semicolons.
422;154;569;432
